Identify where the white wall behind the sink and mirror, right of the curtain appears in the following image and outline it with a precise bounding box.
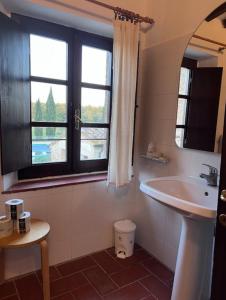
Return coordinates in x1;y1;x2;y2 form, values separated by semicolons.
133;0;223;269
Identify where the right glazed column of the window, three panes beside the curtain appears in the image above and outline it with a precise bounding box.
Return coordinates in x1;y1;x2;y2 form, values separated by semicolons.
79;45;111;165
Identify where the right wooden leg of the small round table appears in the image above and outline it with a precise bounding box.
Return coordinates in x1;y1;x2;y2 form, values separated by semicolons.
40;240;50;300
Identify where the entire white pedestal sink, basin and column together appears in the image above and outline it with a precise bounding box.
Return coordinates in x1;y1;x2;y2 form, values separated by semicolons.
140;176;218;300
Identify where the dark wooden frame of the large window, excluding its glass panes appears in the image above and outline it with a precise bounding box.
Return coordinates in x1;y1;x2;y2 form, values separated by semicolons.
12;14;113;179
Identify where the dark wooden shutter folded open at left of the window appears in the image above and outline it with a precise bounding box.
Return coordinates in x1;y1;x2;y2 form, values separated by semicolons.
0;14;31;175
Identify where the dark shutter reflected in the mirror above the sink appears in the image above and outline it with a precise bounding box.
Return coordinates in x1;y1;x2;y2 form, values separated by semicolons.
184;68;222;151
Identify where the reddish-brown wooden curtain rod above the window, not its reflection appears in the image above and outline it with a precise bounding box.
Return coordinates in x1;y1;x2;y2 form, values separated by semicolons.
84;0;154;24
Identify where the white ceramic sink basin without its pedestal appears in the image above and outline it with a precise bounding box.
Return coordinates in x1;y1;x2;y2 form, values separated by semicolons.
140;176;218;219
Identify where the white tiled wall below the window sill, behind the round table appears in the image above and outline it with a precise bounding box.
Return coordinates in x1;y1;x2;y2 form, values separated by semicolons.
0;182;136;277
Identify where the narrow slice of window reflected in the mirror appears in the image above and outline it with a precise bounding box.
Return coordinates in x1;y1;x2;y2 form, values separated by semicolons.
176;57;197;147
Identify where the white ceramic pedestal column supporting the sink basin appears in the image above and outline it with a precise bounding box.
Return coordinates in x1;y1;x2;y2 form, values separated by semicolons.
171;215;214;300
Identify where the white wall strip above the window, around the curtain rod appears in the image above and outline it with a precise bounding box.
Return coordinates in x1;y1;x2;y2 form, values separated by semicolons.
0;0;148;36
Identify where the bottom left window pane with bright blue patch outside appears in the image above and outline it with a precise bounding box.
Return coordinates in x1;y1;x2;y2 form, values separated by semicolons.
32;127;67;164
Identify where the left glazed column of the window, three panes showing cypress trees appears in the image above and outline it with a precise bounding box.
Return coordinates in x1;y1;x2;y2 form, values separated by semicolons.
30;34;69;165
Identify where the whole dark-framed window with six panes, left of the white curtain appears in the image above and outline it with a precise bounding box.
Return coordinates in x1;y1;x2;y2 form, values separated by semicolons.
14;16;112;179
